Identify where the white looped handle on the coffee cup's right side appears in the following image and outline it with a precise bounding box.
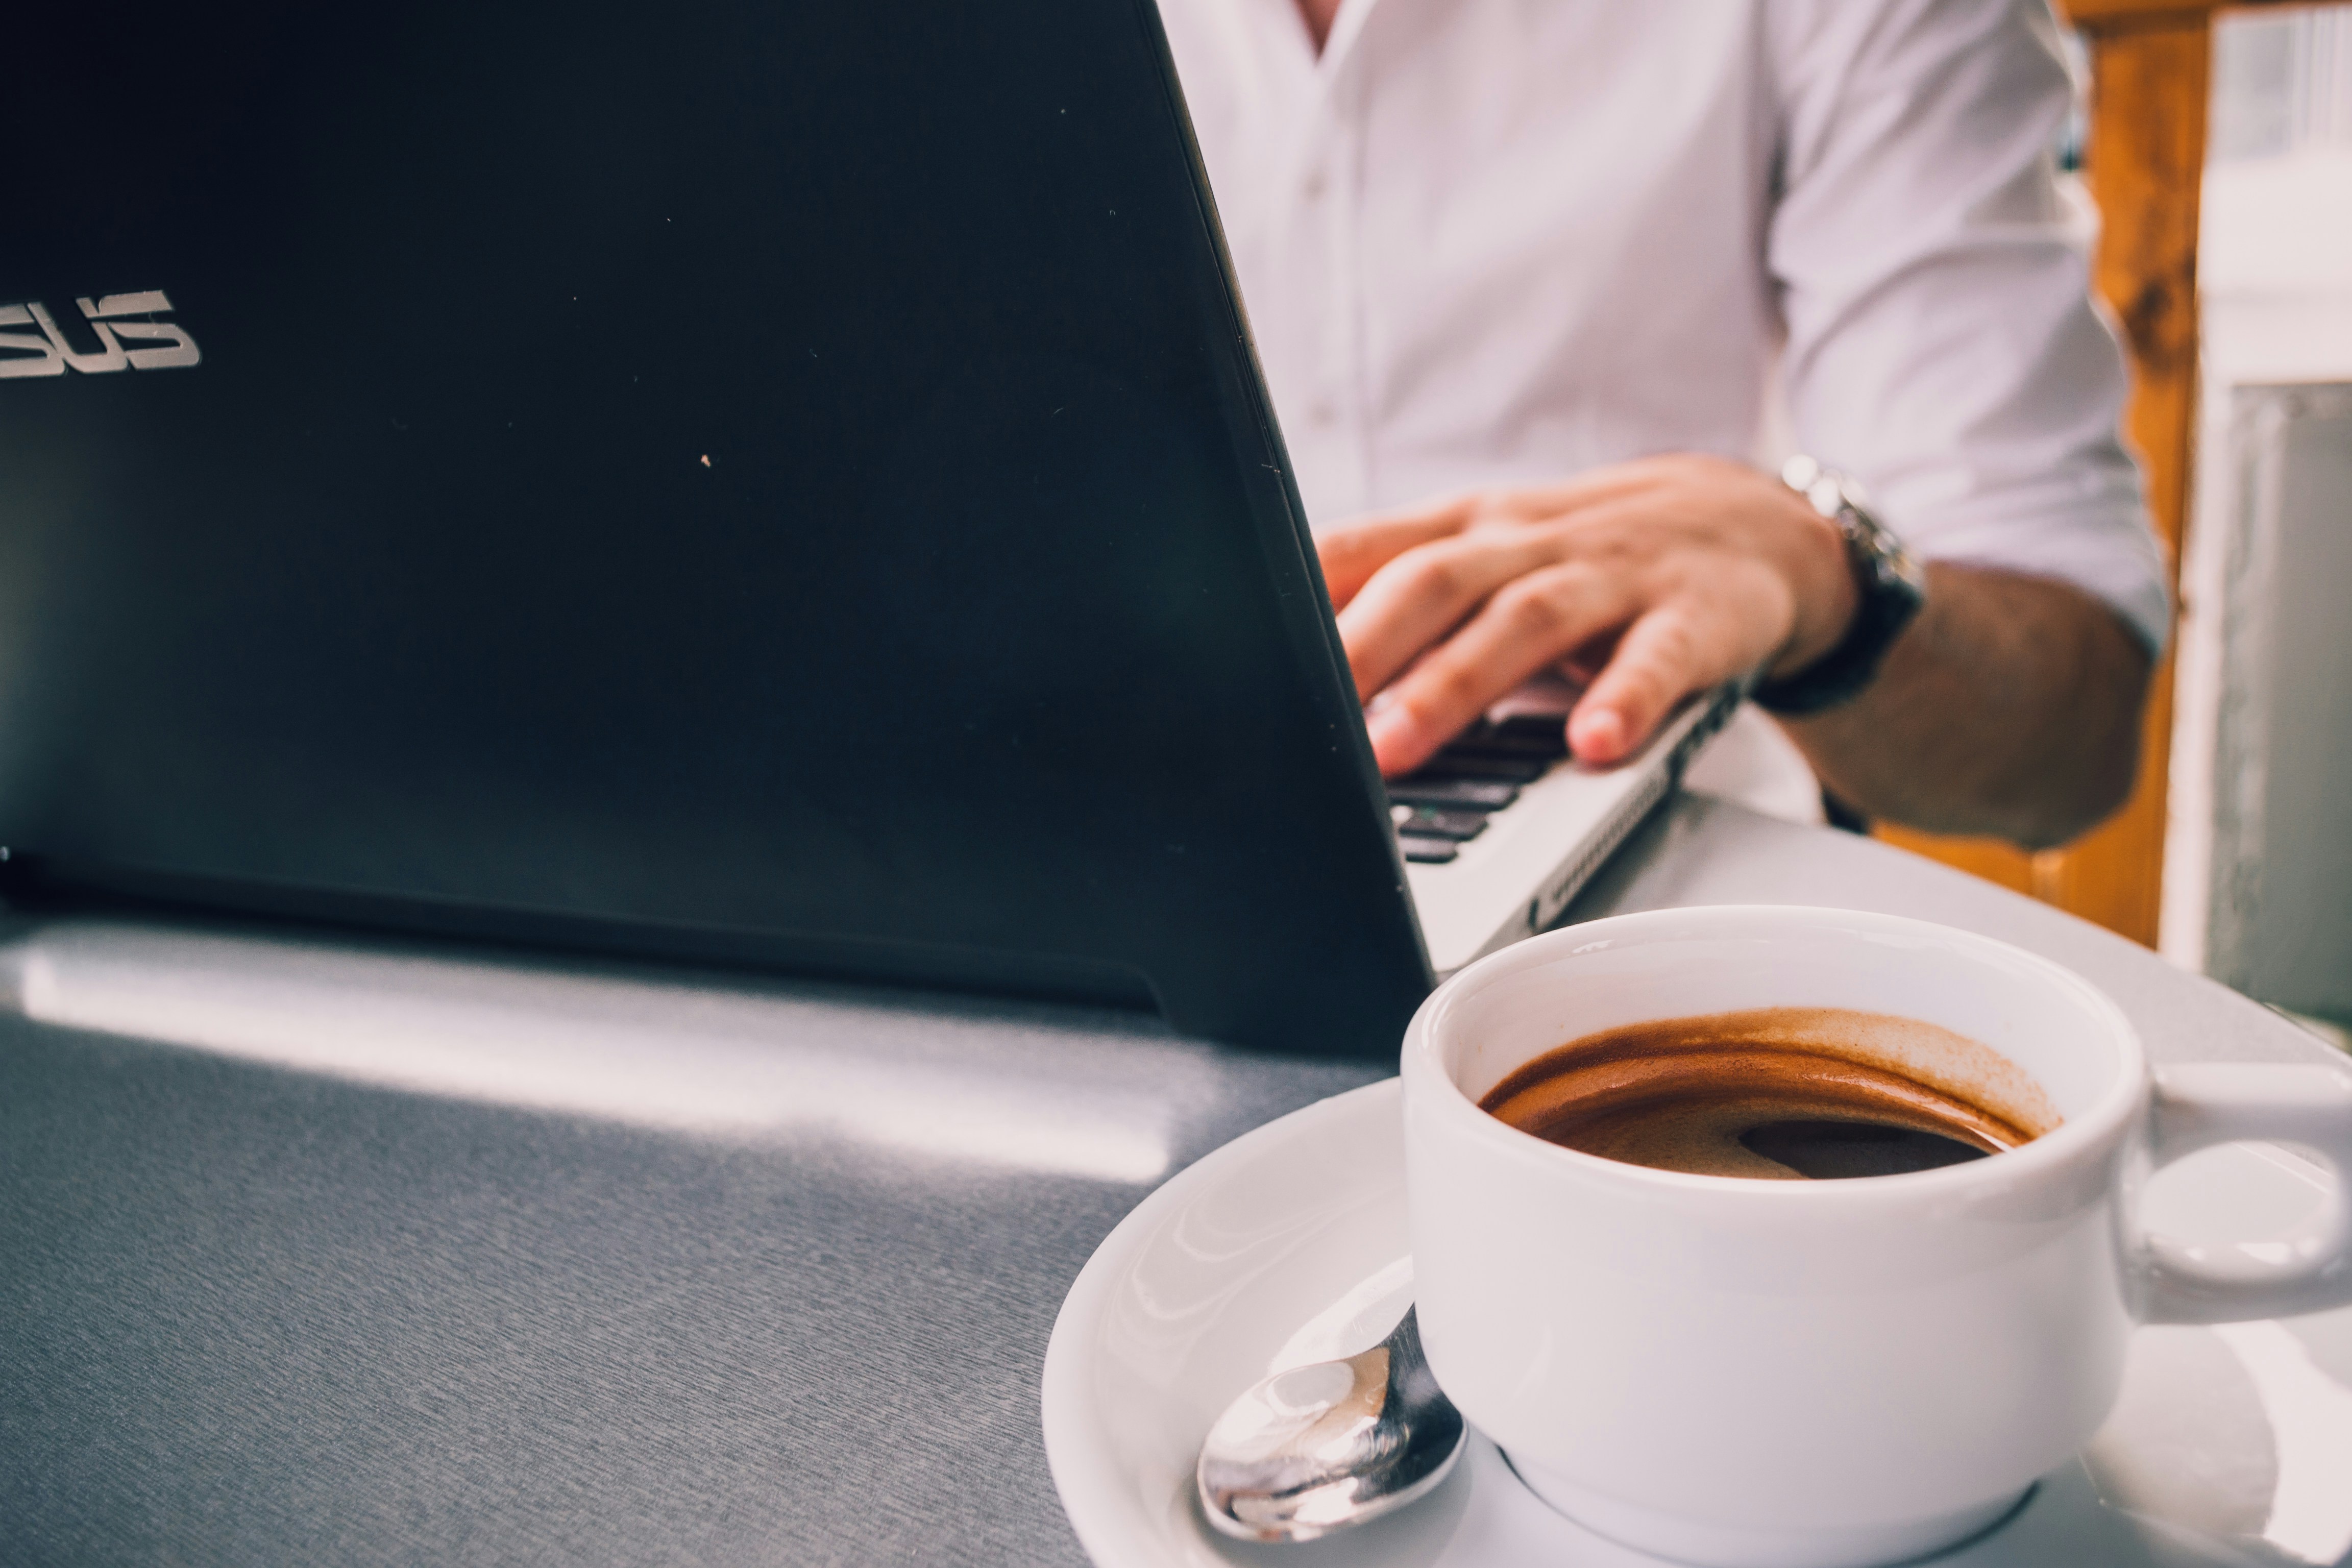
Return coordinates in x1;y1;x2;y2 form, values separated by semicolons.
2140;1063;2352;1324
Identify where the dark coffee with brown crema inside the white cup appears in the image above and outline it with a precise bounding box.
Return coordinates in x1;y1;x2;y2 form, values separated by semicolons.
1479;1006;2061;1180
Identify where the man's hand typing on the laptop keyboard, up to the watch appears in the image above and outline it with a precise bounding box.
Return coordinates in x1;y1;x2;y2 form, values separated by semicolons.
1317;454;1856;776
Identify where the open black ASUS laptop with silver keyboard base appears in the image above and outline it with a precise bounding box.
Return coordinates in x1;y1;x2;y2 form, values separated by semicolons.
0;0;1729;1058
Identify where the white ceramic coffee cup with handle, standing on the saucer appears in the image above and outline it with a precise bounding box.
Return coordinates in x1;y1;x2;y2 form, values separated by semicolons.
1404;908;2352;1568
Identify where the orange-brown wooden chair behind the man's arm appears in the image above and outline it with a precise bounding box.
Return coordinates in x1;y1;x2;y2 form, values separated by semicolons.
1879;0;2263;945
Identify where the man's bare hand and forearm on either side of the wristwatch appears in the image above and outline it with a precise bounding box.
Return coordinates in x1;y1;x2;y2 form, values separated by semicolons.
1322;456;2152;846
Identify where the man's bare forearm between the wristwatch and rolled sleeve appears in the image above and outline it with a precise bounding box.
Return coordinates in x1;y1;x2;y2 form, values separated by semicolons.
1785;564;2150;849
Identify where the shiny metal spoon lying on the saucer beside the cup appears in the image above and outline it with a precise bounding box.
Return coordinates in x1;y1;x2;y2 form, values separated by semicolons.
1195;1309;1465;1540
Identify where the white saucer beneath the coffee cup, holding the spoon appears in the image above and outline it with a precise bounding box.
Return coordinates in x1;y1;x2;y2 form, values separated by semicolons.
1044;1079;2352;1568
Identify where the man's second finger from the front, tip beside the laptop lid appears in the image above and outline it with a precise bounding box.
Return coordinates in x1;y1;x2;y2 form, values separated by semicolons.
1366;564;1639;773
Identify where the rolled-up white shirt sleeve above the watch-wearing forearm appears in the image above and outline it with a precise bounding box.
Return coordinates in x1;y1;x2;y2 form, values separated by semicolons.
1764;0;2171;649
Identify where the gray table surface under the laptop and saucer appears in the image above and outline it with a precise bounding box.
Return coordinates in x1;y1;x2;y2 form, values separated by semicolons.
0;797;2321;1568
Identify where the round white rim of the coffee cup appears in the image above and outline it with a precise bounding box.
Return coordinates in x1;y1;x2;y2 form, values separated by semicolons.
1400;903;2147;1204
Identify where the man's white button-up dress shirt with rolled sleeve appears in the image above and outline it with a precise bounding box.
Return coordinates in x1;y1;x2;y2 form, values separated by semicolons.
1160;0;2169;647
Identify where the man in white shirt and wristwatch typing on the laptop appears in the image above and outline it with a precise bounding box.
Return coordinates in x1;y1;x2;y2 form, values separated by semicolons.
1162;0;2169;846
